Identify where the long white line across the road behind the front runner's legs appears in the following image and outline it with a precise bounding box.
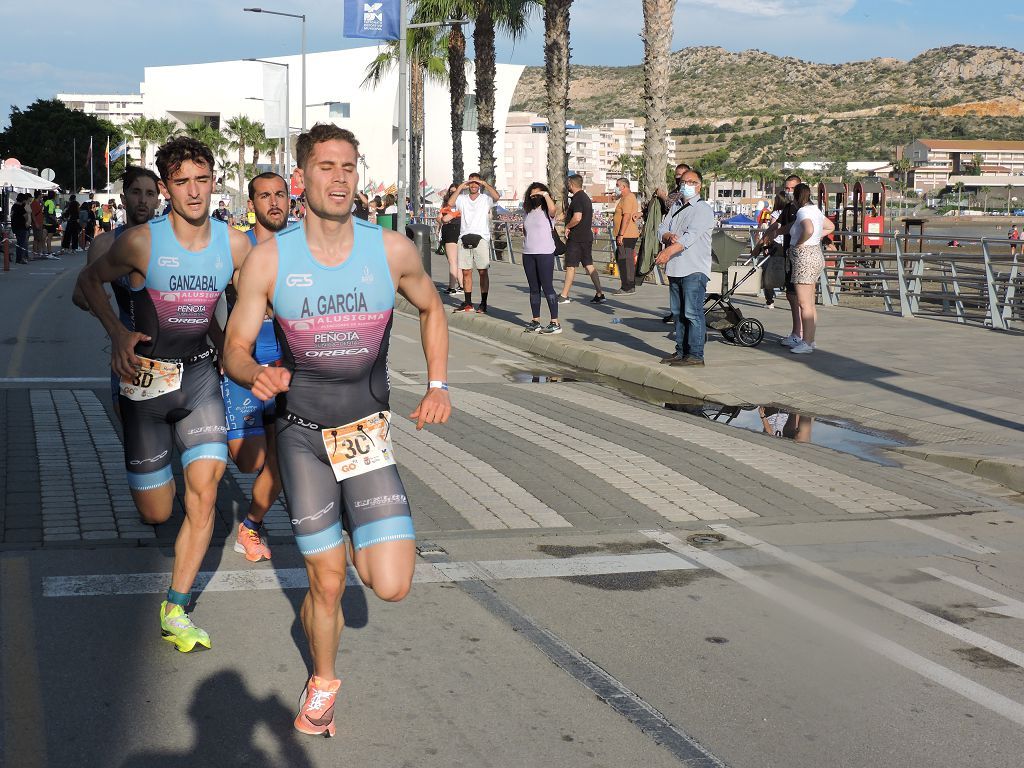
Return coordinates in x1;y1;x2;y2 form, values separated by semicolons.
43;552;697;597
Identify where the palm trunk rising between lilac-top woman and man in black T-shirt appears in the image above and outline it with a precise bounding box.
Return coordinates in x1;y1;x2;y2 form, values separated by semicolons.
544;0;572;210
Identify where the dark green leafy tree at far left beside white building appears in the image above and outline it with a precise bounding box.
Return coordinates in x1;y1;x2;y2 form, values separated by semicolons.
0;98;125;188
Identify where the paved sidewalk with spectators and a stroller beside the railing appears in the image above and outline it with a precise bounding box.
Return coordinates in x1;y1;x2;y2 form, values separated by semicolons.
433;257;1024;490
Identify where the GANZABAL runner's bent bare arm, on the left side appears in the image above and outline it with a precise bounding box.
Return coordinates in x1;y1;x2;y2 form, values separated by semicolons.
77;226;151;376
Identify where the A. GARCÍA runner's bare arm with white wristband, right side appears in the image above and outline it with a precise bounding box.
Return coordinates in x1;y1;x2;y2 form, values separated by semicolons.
384;230;452;429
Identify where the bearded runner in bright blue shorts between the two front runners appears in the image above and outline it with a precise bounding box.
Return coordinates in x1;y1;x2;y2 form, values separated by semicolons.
220;171;288;562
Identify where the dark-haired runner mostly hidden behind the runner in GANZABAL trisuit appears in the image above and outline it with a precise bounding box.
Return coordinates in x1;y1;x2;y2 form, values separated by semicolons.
72;165;160;419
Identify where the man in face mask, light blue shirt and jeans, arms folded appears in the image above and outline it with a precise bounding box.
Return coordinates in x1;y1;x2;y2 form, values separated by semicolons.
654;170;715;368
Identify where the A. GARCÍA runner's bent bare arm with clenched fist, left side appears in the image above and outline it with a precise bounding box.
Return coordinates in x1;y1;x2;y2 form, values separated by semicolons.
224;240;288;400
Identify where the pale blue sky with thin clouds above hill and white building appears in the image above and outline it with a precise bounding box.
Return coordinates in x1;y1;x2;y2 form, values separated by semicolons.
0;0;1024;127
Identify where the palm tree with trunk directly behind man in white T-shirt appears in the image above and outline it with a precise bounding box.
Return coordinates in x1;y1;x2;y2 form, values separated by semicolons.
473;0;536;184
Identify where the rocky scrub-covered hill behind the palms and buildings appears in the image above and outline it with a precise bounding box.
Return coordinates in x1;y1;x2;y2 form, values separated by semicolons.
513;45;1024;164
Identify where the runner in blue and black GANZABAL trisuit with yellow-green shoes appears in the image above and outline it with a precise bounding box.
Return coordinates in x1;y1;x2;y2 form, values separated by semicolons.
79;136;251;651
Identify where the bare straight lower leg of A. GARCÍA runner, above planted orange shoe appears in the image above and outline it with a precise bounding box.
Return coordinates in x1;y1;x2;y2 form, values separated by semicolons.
299;546;345;680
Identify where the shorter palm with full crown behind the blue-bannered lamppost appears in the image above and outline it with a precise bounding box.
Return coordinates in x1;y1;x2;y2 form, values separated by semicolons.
362;25;447;216
